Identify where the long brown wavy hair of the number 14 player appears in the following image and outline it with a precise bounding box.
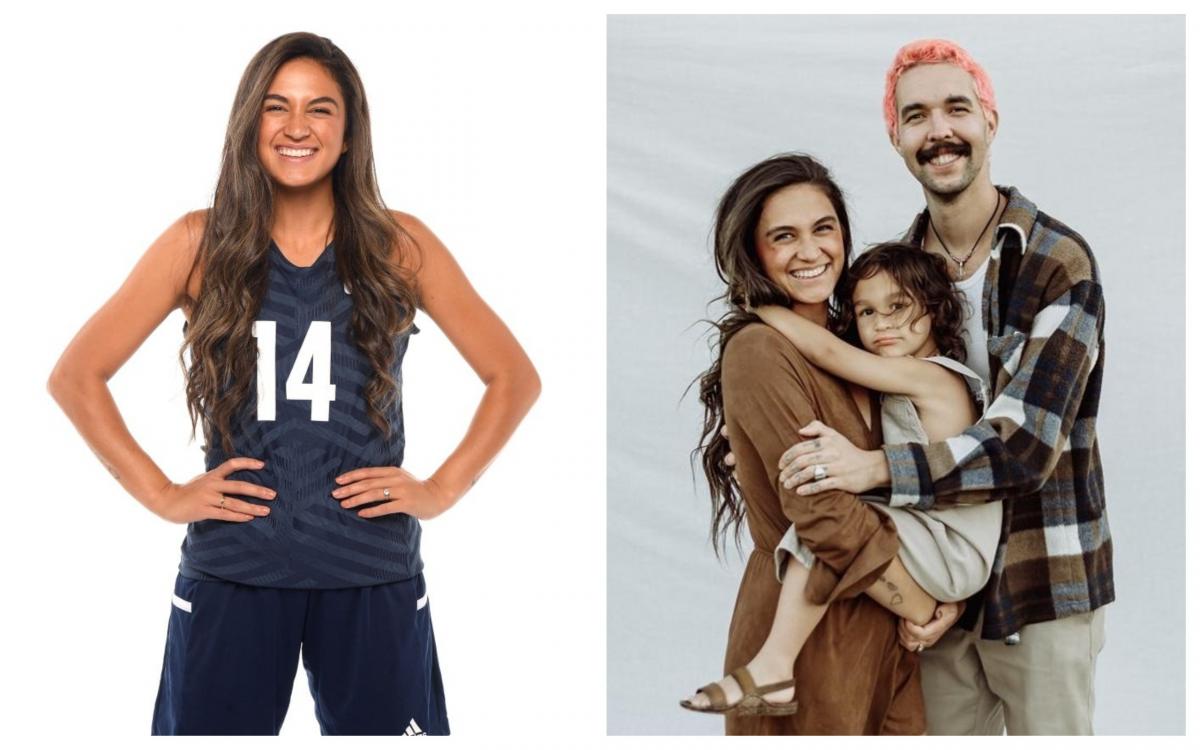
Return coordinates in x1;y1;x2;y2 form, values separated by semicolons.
179;32;419;452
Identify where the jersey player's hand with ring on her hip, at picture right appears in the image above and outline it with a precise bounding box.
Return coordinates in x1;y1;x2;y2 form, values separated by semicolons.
334;466;455;521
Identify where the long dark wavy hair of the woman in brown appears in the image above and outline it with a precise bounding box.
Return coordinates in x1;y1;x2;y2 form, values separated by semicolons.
692;154;851;554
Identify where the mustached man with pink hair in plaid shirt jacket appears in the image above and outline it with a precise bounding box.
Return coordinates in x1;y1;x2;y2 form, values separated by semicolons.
781;40;1114;734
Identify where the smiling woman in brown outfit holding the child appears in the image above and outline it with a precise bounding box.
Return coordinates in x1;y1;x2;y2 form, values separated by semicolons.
700;155;924;734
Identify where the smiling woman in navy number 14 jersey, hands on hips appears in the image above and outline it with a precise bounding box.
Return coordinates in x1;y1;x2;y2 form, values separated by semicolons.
43;34;540;734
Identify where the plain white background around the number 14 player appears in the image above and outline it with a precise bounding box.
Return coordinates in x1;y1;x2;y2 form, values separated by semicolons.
0;2;605;744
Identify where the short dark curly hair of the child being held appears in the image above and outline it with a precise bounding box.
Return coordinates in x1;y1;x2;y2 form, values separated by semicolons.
839;242;967;362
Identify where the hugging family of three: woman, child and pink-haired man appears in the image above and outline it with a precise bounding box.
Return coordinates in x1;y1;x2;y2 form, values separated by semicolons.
680;40;1114;734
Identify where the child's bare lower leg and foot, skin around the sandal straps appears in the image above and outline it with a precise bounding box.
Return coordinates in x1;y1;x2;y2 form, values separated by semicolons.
690;557;829;708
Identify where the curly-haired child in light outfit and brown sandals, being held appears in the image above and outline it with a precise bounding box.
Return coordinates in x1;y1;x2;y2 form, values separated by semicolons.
680;242;1001;715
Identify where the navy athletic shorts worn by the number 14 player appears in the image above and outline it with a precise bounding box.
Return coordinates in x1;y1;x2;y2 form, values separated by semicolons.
151;575;450;734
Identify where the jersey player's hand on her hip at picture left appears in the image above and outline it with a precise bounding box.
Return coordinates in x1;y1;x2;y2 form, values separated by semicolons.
150;457;275;523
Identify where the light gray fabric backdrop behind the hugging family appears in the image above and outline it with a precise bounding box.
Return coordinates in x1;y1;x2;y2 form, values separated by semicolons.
607;16;1184;734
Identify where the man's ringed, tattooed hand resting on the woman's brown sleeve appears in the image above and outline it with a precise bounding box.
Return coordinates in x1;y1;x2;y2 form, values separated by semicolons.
779;421;889;494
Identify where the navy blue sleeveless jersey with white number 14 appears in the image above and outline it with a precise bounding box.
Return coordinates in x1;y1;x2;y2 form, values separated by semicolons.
179;241;421;588
